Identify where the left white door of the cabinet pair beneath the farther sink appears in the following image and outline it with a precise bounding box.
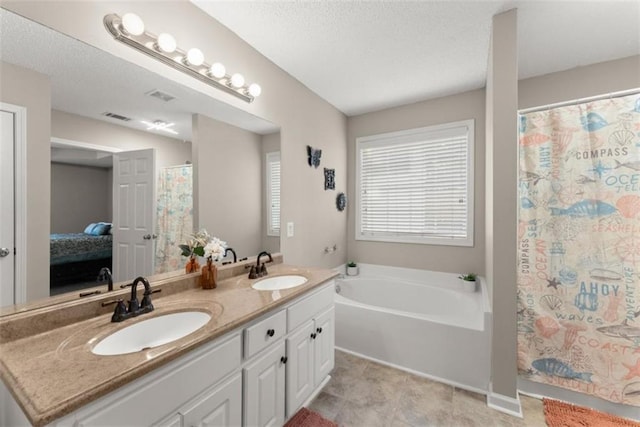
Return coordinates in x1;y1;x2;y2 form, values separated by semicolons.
287;320;317;417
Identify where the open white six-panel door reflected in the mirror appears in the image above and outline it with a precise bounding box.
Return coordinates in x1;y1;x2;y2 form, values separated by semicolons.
112;148;156;281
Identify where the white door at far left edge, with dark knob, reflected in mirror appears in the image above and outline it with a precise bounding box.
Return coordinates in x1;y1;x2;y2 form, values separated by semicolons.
0;111;15;307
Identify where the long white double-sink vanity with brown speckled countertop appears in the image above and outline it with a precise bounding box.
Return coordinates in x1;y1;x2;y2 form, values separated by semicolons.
0;256;337;426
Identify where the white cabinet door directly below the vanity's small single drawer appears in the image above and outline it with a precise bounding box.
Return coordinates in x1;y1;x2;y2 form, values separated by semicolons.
244;341;286;427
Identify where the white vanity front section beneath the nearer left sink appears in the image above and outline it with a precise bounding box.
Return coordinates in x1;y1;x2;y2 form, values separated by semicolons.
53;332;242;427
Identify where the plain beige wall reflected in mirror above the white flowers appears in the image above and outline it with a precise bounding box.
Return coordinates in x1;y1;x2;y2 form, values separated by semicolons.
193;115;263;258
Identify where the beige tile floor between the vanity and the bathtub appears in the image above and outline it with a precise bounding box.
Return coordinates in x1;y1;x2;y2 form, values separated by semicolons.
309;351;546;427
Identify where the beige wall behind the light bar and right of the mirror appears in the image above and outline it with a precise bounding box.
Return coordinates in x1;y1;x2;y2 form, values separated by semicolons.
2;0;347;267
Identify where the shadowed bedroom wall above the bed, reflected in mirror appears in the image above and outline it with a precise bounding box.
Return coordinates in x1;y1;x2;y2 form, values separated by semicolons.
51;163;112;233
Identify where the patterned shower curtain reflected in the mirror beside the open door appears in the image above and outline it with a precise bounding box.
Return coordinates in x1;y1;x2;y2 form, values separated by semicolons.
155;165;193;274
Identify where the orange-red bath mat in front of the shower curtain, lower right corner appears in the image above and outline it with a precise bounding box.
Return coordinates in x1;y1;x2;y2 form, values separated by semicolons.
542;399;640;427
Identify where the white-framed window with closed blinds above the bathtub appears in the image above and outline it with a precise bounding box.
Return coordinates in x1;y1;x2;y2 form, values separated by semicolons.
356;120;474;246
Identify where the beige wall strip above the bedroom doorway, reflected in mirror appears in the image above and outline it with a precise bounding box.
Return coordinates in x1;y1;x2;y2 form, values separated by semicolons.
51;110;191;169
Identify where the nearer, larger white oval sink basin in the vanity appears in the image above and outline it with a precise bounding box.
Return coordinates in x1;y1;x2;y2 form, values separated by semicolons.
91;311;211;356
